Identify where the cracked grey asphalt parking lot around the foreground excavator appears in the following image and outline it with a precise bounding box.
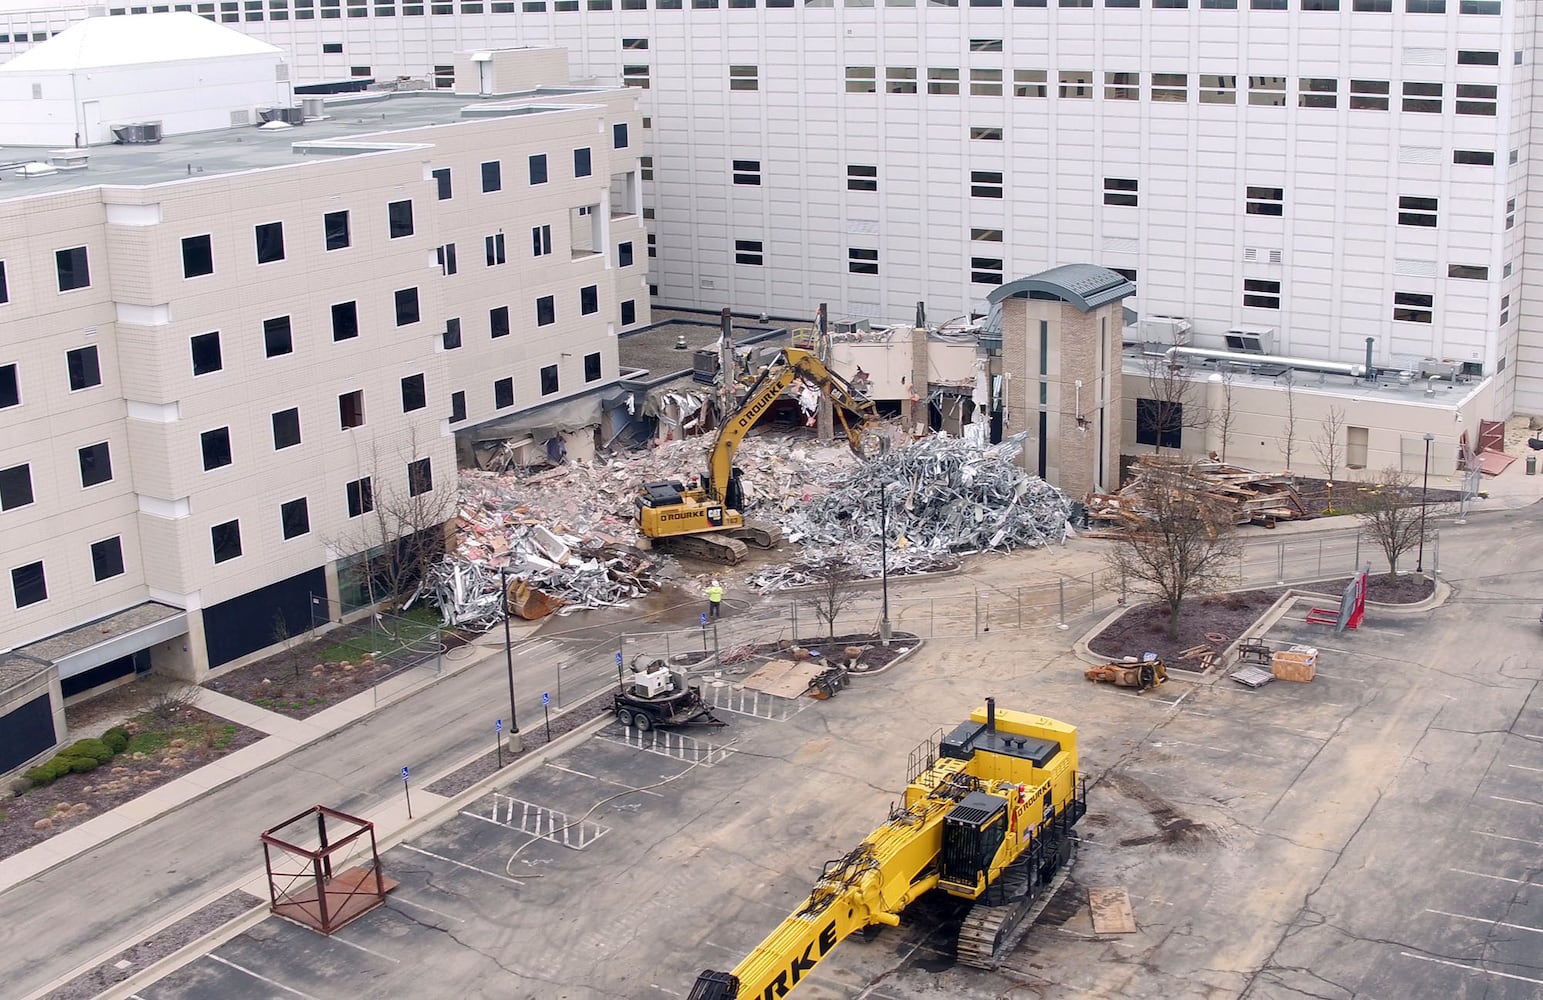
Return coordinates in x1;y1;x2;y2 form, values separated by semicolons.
137;561;1543;1000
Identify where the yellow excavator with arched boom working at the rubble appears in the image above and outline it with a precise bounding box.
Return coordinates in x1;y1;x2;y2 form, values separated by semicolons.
637;347;878;565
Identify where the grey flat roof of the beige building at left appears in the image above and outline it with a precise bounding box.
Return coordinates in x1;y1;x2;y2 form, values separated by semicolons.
0;86;613;199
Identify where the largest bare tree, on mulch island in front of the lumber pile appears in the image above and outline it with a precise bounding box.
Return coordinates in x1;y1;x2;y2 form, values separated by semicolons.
1108;466;1237;636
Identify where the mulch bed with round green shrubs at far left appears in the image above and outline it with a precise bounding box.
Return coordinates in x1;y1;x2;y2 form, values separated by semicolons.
0;708;264;858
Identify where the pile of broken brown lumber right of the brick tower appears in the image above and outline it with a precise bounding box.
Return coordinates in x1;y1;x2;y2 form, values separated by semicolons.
1088;455;1307;537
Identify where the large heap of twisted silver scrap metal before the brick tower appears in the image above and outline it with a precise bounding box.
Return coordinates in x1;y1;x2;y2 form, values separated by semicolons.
748;434;1072;590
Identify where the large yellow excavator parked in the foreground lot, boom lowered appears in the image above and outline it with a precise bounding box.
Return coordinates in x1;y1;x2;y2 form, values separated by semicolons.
690;698;1088;1000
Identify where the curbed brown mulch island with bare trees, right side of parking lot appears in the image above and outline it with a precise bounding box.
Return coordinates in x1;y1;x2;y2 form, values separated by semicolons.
1088;574;1435;671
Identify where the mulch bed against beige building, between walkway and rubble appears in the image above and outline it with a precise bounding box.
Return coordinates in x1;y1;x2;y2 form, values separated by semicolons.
204;616;466;719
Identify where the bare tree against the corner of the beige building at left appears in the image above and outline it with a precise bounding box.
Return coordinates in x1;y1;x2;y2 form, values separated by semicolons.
332;432;455;605
